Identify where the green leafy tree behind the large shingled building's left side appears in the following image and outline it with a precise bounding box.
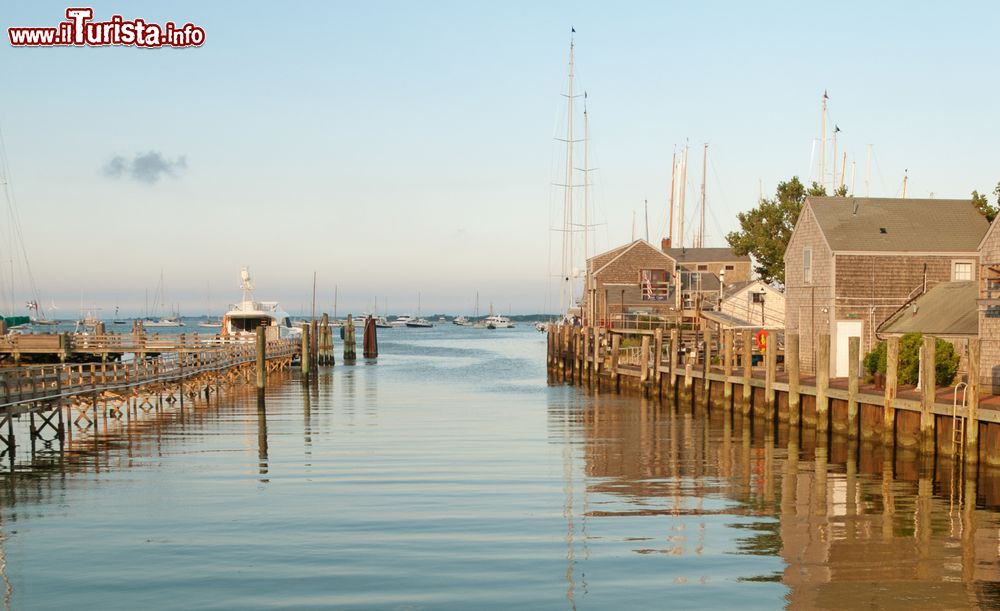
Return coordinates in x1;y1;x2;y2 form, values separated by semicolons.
726;176;847;283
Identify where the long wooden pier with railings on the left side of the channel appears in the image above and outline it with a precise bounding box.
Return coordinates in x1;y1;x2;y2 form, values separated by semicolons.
0;333;300;469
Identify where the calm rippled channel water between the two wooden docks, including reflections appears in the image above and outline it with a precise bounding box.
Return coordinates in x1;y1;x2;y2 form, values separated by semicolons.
0;324;1000;609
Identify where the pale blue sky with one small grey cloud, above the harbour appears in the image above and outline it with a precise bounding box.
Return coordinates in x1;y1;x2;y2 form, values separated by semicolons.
0;0;1000;318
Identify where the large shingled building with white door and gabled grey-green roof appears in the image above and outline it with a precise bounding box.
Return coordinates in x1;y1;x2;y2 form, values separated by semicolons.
785;197;988;377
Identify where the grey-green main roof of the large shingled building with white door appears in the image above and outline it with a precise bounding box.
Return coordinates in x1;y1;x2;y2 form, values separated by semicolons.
806;197;989;252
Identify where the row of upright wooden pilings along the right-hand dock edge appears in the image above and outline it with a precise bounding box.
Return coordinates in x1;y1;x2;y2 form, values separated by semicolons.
547;325;1000;464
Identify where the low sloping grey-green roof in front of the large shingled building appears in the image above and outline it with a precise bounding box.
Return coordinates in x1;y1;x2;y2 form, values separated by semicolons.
879;280;979;335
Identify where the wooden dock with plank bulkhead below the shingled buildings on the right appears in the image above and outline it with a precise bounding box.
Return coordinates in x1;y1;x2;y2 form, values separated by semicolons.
547;325;1000;466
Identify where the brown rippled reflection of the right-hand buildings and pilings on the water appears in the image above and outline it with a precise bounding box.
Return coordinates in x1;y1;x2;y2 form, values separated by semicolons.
549;382;1000;609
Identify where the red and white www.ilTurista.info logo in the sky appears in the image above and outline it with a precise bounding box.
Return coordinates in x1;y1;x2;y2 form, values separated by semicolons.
7;8;205;48
